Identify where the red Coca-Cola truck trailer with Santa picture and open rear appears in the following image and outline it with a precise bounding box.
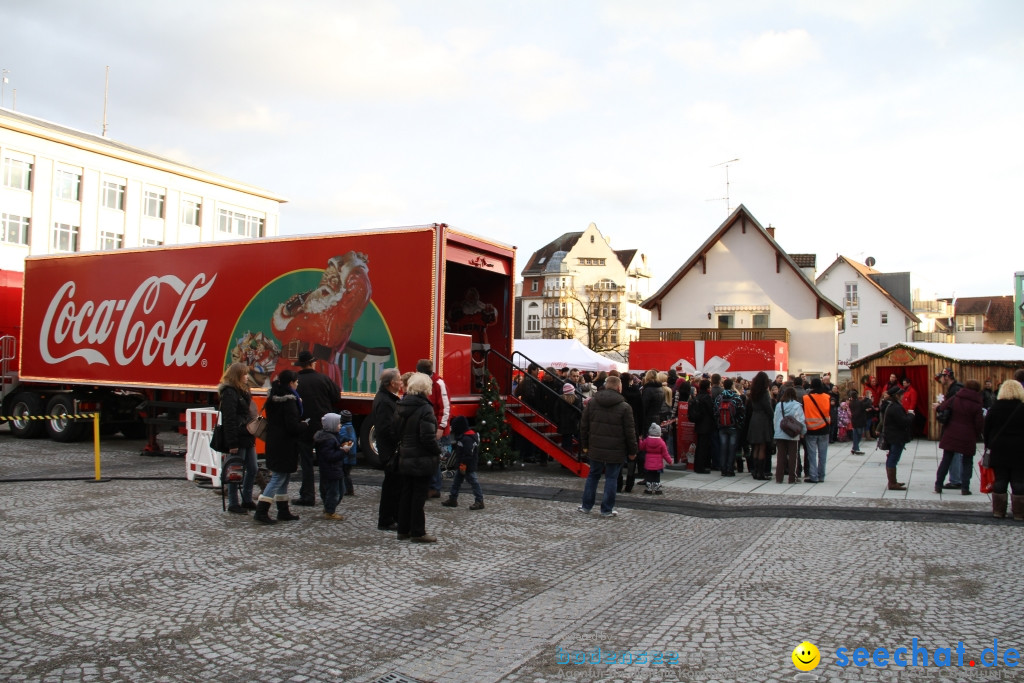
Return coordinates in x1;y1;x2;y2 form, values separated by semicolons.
0;223;515;458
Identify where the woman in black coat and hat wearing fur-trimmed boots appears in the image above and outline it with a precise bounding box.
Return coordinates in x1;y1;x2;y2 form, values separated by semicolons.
254;370;308;524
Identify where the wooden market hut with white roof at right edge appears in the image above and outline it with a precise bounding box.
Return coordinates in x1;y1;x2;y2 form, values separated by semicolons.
850;342;1024;440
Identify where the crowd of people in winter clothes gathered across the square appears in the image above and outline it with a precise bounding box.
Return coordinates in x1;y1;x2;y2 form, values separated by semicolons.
211;352;1024;532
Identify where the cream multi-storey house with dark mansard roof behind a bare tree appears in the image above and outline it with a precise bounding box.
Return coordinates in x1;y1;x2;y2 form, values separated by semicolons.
516;223;650;353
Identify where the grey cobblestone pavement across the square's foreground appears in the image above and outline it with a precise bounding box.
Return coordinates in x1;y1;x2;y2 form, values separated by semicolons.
0;432;1024;683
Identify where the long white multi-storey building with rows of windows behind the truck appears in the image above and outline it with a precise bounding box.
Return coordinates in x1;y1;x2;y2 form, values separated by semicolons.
0;110;286;271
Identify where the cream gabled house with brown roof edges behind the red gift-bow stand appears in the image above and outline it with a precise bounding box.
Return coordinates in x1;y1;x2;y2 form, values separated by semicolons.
642;205;843;375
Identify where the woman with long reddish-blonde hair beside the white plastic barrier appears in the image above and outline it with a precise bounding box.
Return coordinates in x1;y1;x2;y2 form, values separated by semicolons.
217;362;256;515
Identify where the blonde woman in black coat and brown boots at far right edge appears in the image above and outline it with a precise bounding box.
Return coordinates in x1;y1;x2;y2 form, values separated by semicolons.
984;380;1024;521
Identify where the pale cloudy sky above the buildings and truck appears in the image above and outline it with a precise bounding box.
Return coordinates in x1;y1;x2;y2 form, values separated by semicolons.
0;0;1024;299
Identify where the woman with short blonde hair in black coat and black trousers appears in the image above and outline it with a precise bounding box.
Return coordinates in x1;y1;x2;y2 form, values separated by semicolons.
395;373;441;543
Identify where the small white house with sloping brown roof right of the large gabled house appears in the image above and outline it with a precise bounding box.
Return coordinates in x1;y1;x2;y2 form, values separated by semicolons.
815;256;921;375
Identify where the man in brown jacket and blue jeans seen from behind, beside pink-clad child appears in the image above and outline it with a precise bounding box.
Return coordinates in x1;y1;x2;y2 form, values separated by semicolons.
577;377;637;517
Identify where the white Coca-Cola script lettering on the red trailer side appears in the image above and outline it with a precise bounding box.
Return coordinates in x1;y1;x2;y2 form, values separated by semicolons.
39;273;217;368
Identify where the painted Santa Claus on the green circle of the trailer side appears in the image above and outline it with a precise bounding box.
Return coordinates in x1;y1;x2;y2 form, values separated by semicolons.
271;251;372;386
